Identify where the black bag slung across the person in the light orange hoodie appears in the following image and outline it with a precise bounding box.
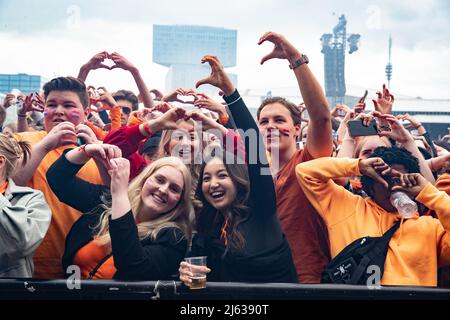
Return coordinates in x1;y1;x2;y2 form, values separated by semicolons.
321;221;400;285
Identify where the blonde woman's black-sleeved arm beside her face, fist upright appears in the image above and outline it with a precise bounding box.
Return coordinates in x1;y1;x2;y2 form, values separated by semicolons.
109;158;187;280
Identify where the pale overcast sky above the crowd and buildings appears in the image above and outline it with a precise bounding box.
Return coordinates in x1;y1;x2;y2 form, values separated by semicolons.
0;0;450;98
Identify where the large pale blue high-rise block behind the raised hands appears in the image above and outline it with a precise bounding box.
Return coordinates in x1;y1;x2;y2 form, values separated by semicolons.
153;25;237;93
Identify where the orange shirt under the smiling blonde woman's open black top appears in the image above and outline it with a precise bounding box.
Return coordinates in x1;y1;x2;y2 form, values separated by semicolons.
73;241;117;279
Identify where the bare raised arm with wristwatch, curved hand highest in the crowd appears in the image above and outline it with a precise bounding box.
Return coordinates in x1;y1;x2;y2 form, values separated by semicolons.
258;32;333;158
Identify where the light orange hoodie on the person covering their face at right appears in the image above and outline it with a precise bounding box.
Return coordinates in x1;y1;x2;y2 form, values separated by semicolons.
295;158;450;286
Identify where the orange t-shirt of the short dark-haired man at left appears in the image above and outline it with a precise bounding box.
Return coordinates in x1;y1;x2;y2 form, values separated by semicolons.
16;131;102;279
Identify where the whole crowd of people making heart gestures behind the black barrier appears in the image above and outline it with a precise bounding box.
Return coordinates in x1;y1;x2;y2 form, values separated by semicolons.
0;32;450;287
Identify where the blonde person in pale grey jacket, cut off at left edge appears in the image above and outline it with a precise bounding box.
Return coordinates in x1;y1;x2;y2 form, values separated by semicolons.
0;134;52;278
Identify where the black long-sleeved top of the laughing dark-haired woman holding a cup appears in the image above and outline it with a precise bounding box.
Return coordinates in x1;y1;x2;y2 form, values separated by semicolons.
191;90;297;283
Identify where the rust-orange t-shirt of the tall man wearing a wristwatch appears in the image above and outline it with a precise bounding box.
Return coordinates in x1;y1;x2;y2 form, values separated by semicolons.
275;148;330;283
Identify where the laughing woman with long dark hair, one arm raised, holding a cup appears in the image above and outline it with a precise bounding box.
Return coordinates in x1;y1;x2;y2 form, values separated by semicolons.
180;56;297;285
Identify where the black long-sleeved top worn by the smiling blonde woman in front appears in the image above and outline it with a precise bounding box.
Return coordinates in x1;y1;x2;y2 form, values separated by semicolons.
47;150;188;280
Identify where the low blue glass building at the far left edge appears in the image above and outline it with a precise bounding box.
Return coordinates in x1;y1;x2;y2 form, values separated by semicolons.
0;73;45;94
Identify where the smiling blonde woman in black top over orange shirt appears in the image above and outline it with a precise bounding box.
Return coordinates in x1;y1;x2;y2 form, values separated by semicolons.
47;144;191;280
